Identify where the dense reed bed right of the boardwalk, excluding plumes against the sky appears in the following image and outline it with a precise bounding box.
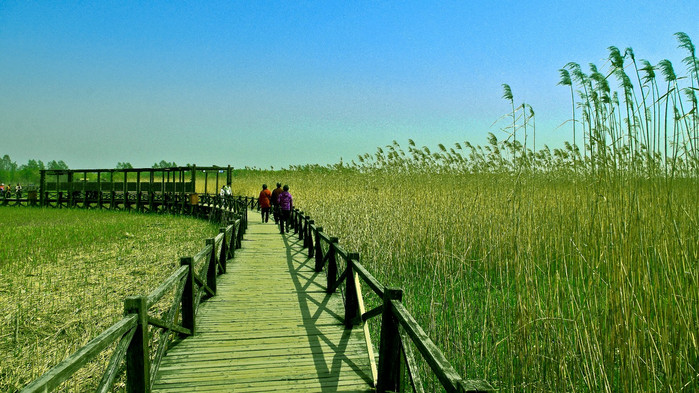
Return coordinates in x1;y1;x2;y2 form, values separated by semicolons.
227;168;699;392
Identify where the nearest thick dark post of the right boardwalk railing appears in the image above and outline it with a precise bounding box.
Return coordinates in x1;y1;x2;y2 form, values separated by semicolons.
376;288;403;393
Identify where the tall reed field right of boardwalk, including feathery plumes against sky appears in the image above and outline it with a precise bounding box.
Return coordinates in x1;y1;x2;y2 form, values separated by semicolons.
226;33;699;392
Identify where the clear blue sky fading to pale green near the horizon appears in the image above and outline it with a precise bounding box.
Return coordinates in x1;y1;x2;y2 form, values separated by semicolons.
0;0;699;168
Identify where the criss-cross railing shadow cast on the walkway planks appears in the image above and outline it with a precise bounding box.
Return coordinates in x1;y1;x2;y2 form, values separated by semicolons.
283;234;372;392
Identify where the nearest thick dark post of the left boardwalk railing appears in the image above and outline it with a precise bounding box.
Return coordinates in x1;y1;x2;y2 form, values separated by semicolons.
124;296;150;393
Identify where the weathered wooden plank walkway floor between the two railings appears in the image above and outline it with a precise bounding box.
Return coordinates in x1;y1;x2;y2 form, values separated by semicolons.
153;212;374;392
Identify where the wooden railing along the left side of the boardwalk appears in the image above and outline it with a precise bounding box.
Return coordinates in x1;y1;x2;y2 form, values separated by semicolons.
21;196;247;393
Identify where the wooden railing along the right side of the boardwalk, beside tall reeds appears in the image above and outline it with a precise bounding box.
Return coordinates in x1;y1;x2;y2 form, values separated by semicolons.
291;204;494;392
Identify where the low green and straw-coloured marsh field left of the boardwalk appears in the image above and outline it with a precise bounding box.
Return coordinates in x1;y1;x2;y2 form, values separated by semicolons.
0;207;218;392
